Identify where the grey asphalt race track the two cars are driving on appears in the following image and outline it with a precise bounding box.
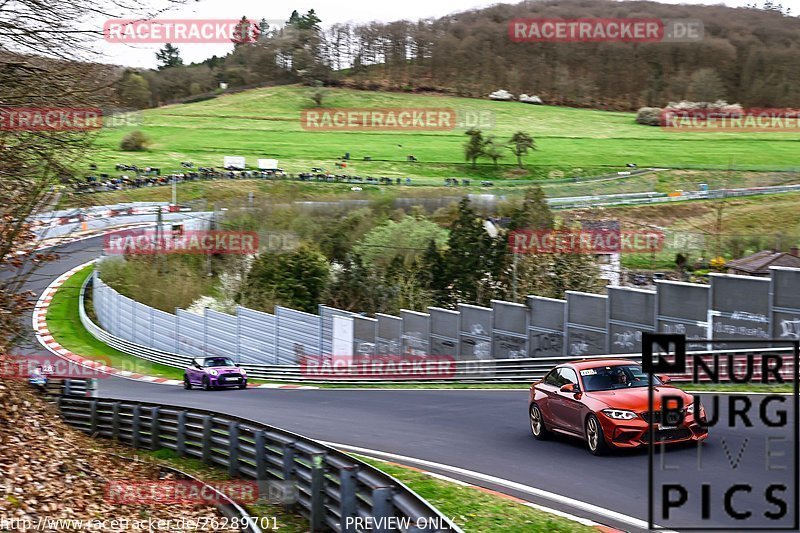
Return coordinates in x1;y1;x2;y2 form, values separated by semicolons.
15;238;798;531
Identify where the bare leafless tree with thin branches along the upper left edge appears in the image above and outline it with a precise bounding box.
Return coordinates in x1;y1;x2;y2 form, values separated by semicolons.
0;0;194;352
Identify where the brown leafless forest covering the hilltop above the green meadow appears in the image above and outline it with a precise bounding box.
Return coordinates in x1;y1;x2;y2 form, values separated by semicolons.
118;0;800;110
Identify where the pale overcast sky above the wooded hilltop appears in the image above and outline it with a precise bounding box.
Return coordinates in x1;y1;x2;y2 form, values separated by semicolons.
98;0;800;68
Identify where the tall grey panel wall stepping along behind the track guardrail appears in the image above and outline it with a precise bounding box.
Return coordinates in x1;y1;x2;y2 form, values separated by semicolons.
93;267;800;365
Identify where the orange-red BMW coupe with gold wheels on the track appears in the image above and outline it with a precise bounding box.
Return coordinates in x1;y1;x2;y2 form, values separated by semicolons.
529;359;708;455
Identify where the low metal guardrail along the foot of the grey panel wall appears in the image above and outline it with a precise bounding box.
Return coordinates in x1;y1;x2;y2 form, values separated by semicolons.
79;270;787;384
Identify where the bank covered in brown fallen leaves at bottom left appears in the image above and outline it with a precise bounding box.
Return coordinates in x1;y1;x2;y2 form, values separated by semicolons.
0;372;228;531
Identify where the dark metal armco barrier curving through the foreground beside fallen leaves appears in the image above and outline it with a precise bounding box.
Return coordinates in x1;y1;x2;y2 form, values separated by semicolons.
58;396;461;533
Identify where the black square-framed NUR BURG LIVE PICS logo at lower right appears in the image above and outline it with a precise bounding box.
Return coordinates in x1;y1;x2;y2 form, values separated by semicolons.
642;333;800;531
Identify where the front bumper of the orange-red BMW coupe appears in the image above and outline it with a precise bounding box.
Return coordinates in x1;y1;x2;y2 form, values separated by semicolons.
597;413;708;448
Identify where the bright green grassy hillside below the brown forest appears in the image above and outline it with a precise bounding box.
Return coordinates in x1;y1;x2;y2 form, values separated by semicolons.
87;86;800;185
